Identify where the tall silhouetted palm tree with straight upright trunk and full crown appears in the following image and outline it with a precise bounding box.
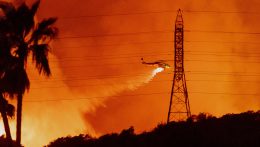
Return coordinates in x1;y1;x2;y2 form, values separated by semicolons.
0;0;57;145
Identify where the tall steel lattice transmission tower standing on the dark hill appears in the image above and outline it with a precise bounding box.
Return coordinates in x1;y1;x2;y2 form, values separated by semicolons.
167;9;191;123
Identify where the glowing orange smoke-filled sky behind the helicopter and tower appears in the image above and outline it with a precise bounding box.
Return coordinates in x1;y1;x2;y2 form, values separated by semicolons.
1;0;260;146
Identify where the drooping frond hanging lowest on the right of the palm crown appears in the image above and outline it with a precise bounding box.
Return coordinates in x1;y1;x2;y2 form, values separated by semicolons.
31;44;51;76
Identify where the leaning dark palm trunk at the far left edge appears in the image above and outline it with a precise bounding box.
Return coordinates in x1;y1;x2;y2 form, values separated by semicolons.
0;94;12;147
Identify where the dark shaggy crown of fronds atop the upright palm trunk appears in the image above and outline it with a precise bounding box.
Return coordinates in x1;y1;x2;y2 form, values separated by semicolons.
0;0;55;97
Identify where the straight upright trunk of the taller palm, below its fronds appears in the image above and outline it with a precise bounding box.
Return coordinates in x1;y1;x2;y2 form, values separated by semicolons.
16;93;23;146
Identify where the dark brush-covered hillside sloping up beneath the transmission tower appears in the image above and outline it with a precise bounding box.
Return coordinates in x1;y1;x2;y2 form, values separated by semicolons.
46;111;260;147
